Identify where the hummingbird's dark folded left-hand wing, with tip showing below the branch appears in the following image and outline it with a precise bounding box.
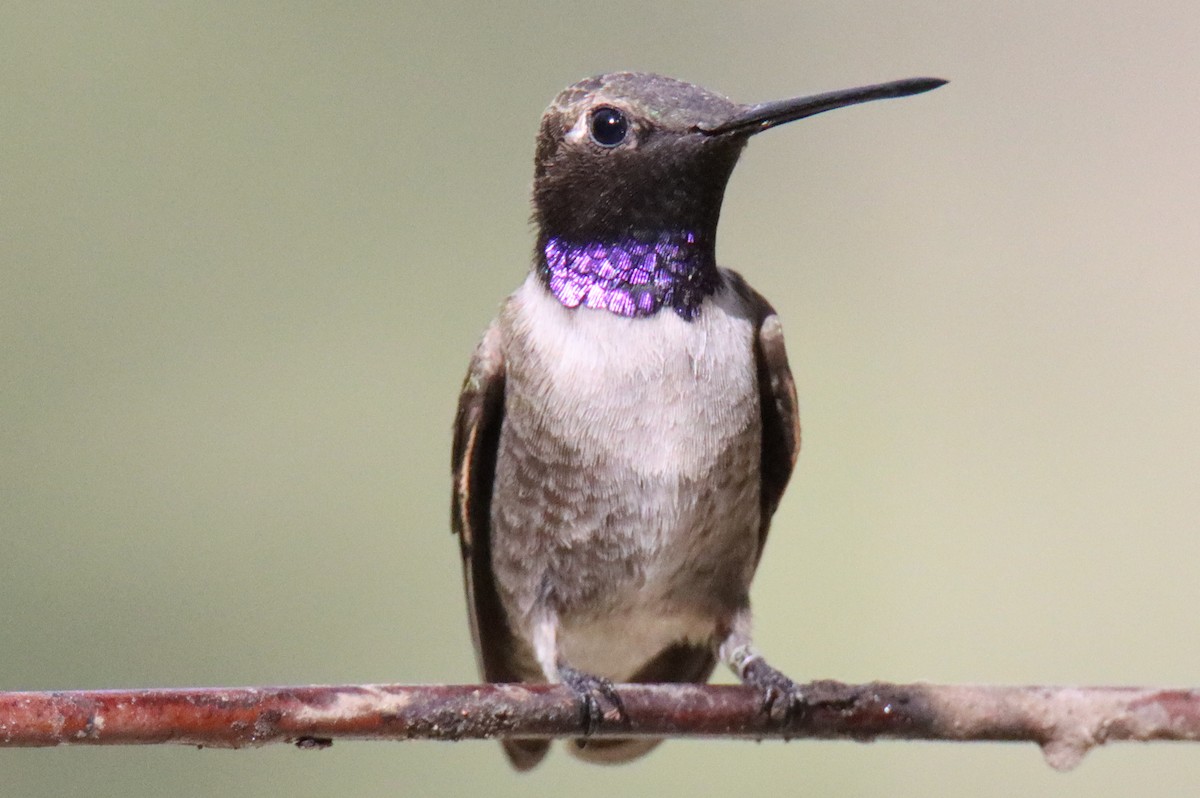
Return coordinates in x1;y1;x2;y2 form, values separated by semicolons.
450;322;550;770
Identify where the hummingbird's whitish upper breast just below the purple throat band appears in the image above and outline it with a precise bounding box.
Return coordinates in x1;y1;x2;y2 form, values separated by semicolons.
512;275;758;476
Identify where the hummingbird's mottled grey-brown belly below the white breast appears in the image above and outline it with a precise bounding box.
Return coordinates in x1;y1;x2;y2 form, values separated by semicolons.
492;424;758;679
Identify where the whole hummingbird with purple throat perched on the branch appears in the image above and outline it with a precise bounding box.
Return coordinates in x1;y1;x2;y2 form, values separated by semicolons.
451;72;946;770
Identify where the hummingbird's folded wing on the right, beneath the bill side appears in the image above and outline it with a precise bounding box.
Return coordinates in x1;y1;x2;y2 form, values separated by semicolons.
726;270;800;554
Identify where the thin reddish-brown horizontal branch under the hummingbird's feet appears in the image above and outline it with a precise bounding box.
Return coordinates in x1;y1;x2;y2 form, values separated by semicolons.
0;682;1200;770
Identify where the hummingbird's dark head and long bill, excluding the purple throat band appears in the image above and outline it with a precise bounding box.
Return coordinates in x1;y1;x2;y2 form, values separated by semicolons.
533;72;944;240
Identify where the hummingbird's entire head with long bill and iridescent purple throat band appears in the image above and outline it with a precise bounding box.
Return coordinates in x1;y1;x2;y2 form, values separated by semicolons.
533;72;944;319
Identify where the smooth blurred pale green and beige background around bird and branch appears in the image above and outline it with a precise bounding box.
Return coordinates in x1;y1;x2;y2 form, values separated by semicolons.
0;0;1200;796
